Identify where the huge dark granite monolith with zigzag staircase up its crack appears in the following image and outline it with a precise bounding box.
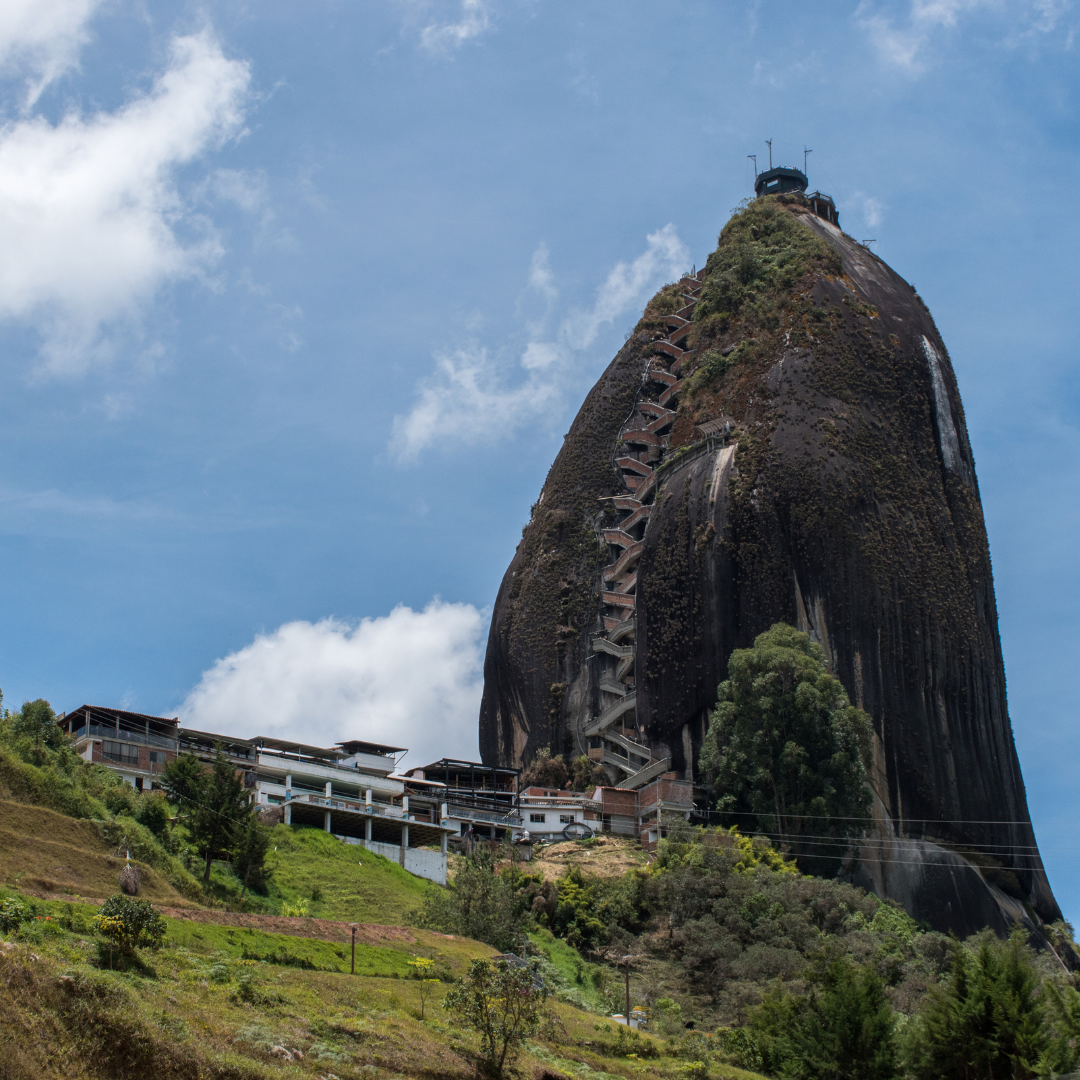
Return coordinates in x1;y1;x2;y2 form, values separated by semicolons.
480;194;1061;934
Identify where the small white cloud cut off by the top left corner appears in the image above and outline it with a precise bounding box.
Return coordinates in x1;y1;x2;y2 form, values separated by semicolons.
0;0;100;104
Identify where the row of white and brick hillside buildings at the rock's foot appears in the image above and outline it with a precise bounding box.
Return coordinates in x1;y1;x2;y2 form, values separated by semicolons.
58;705;693;885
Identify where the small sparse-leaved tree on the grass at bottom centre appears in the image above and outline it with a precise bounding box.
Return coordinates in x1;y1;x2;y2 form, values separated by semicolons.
443;960;548;1077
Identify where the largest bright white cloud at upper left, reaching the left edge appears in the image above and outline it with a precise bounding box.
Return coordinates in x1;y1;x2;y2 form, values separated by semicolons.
0;32;251;372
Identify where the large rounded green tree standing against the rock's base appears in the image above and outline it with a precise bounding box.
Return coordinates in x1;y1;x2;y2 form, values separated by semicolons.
700;623;872;876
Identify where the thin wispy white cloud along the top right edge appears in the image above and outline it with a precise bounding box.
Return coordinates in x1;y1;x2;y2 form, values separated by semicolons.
855;0;1069;72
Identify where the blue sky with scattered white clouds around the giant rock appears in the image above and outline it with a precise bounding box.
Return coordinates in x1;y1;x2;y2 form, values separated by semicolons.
0;0;1080;917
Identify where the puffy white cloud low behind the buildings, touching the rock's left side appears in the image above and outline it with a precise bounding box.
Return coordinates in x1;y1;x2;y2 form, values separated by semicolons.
179;599;486;768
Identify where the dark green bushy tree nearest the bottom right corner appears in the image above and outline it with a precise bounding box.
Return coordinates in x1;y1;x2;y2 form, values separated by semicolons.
907;930;1048;1080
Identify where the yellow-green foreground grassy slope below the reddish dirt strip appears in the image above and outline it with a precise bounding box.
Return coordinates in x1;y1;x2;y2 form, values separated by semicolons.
0;889;768;1080
